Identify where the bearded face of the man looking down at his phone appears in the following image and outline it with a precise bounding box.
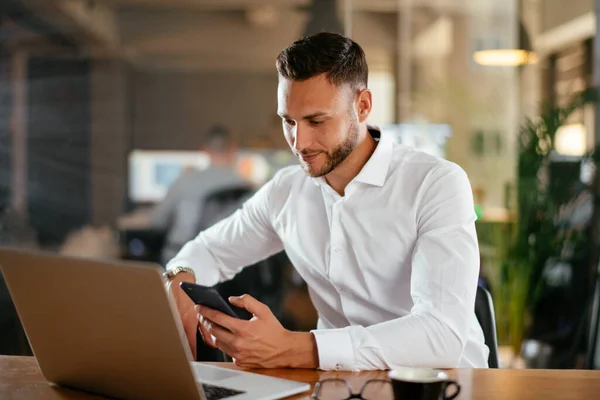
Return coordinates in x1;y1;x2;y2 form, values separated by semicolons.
277;74;359;177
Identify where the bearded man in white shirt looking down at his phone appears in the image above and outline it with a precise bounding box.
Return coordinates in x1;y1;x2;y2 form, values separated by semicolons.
163;33;488;369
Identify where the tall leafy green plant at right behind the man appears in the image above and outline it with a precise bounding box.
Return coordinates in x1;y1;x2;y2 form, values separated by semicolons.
490;88;600;366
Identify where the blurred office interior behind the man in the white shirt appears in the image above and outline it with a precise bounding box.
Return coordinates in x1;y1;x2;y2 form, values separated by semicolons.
0;0;600;368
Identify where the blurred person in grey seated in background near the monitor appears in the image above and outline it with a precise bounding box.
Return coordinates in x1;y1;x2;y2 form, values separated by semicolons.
150;125;250;263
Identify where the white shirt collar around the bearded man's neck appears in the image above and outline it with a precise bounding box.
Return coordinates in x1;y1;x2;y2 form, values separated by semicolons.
312;128;394;186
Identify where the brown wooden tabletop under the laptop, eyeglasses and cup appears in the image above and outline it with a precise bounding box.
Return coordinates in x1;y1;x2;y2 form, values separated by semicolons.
0;356;600;400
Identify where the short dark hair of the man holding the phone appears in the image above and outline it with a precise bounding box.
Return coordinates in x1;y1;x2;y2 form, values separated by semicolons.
277;32;369;88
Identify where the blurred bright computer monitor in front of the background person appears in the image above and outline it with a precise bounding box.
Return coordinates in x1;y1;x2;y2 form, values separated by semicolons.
128;150;210;203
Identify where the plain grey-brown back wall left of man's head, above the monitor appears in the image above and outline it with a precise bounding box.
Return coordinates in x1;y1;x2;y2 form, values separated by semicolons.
133;71;285;150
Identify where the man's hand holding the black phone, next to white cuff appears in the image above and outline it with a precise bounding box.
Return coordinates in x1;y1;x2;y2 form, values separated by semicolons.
196;295;319;368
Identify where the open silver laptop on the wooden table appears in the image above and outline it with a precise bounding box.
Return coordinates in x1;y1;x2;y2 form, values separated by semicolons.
0;248;310;400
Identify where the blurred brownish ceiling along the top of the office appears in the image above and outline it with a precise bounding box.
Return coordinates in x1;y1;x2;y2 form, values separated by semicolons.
10;0;506;71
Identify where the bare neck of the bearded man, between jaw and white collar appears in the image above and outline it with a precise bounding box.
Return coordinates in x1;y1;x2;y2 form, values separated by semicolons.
325;125;377;196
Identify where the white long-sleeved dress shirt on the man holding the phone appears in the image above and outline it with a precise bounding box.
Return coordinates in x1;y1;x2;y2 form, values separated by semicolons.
167;132;488;370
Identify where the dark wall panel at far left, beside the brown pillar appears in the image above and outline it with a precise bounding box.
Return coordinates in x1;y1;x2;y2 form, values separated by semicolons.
26;55;92;246
